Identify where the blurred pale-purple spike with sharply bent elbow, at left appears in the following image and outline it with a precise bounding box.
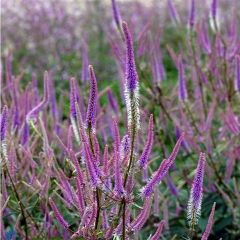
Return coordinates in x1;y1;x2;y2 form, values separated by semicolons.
26;71;49;123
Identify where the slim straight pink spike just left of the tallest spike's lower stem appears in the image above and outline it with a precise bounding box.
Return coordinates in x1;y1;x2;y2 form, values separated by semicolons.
113;119;124;196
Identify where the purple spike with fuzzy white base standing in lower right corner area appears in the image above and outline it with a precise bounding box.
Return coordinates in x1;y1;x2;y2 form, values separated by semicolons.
187;153;206;228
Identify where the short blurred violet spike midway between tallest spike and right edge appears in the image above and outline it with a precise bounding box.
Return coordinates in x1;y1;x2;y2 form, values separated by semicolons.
178;56;187;101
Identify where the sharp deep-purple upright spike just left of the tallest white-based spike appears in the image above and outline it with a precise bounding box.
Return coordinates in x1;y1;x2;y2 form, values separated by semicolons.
86;65;98;132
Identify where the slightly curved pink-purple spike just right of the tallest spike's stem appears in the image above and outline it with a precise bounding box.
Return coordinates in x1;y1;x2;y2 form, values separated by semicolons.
139;114;153;168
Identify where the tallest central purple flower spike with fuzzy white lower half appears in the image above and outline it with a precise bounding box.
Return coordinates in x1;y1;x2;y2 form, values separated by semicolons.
122;22;140;133
